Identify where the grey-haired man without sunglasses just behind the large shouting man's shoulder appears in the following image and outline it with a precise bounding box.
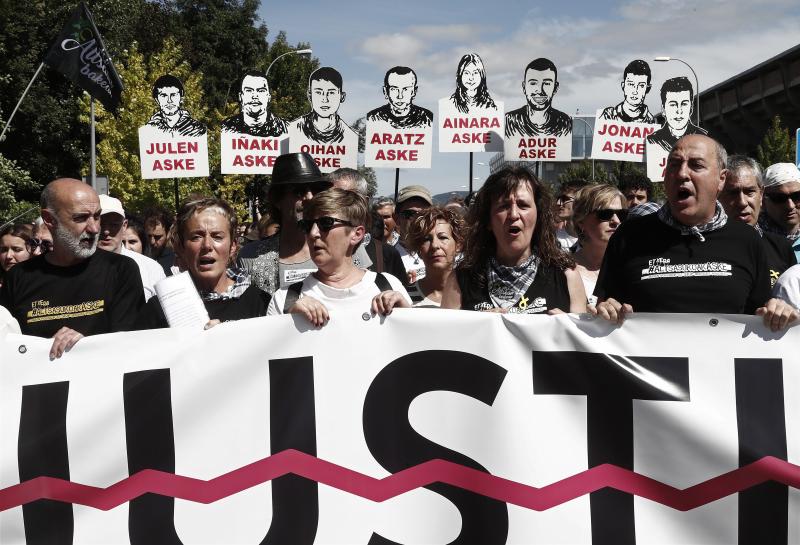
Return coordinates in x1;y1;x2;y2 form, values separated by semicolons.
719;155;797;286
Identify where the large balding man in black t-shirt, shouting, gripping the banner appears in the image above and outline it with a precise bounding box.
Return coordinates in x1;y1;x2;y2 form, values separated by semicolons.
594;135;798;330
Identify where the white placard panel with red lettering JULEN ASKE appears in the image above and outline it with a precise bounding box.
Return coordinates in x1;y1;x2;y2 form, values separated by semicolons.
139;126;208;180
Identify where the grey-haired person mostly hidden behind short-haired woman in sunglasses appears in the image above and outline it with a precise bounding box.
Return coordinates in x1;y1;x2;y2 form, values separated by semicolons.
328;168;406;281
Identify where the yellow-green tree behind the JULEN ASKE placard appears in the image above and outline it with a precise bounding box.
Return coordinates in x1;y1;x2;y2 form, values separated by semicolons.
81;38;219;211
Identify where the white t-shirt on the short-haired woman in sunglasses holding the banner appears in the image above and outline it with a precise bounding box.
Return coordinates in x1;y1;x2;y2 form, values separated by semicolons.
267;271;411;316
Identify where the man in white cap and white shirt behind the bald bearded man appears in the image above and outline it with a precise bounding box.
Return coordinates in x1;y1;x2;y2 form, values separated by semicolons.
97;195;166;301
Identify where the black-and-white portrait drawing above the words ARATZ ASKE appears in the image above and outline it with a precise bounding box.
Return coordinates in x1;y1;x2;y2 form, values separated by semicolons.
367;66;433;129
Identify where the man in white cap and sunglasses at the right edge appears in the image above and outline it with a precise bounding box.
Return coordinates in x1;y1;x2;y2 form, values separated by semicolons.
758;163;800;261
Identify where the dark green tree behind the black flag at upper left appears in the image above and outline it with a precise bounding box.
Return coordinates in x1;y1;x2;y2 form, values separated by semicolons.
0;0;170;187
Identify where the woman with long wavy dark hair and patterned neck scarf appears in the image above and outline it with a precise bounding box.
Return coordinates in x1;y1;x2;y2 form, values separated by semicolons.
442;167;586;314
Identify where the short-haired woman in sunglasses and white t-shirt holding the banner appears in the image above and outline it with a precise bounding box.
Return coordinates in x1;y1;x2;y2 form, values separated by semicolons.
267;188;411;327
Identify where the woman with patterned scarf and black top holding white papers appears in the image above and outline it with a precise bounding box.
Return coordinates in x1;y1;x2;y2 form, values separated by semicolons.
137;198;270;329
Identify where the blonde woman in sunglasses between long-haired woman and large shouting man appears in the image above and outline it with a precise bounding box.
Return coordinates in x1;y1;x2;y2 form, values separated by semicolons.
572;184;628;305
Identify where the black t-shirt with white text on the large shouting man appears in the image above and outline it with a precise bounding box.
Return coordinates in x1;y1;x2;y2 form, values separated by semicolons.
594;214;770;314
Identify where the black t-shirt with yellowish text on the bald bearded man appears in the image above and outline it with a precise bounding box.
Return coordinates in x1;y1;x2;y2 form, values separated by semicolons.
0;250;144;338
